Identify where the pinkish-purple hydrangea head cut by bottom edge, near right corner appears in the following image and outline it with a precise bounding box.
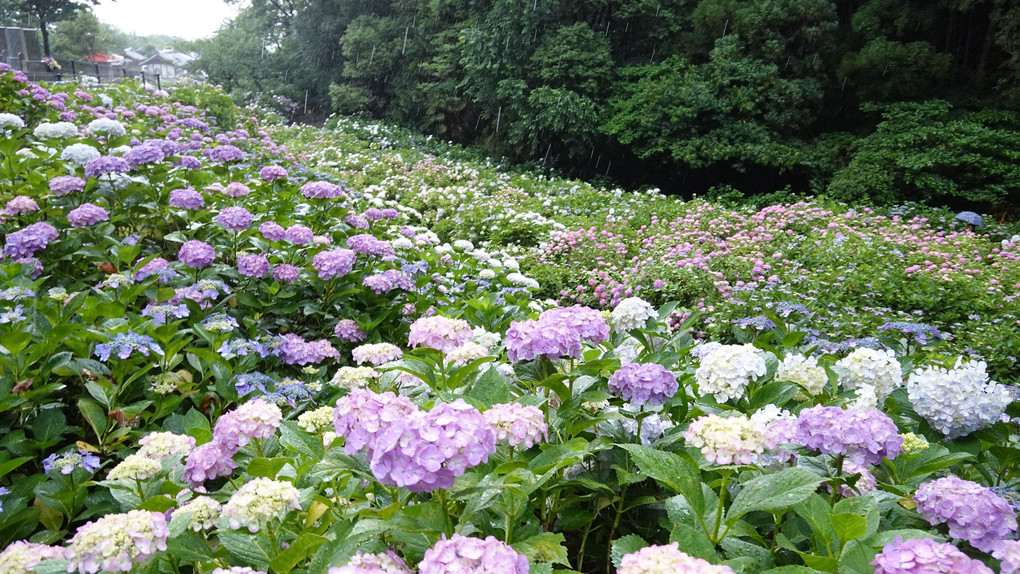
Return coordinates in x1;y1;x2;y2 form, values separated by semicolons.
871;536;991;574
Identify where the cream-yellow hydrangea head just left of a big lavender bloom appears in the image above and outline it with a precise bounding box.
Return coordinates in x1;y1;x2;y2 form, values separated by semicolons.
683;414;775;465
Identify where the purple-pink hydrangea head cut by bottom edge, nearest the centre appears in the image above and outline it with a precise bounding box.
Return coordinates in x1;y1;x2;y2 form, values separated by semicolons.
418;534;530;574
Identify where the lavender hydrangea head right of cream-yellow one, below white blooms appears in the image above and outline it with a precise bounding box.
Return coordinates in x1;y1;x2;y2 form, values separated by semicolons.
795;405;903;466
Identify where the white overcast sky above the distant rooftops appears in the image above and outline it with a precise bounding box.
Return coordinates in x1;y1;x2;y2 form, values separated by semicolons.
92;0;237;40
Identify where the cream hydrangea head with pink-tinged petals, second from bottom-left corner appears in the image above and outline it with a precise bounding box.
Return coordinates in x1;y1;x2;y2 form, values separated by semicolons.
67;510;170;574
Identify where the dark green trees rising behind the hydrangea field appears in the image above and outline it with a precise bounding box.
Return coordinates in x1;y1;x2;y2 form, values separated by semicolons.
192;0;1020;210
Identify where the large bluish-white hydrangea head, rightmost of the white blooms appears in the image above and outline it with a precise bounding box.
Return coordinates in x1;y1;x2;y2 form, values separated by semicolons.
907;360;1014;438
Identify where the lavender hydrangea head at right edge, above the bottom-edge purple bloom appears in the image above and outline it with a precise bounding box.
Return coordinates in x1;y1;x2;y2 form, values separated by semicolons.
914;475;1017;552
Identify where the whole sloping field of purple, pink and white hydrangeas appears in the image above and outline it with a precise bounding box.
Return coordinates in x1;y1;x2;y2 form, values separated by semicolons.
0;66;1020;574
